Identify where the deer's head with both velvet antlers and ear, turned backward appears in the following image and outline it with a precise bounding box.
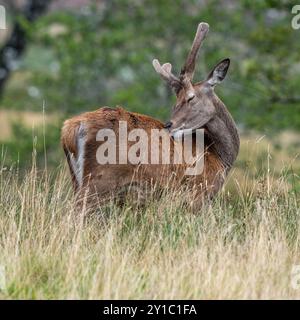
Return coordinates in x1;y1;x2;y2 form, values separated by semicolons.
153;22;230;136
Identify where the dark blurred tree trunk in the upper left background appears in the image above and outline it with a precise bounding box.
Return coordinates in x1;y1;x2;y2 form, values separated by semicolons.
0;0;51;95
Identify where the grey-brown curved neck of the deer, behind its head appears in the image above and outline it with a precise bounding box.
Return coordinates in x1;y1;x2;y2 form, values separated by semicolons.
206;96;240;171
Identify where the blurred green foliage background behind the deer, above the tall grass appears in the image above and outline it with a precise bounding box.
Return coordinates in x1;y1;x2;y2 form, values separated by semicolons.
0;0;300;167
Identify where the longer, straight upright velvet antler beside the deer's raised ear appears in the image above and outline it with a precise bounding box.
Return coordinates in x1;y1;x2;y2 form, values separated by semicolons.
180;22;209;80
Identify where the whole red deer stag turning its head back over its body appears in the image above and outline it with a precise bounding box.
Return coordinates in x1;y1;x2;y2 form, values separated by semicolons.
61;23;239;210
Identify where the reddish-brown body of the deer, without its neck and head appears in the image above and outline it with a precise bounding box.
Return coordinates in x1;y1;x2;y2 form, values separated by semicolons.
62;107;225;208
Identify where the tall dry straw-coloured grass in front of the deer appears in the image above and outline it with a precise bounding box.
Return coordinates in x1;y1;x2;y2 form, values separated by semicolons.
0;134;300;299
